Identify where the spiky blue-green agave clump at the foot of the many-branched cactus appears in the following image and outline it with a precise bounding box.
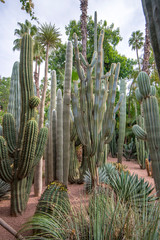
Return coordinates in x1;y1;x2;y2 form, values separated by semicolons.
84;163;157;206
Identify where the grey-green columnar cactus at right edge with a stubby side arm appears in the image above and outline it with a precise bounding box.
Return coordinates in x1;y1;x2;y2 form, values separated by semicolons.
133;72;160;196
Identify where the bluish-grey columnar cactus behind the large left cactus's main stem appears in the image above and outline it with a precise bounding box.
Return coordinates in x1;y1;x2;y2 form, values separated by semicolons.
7;62;21;134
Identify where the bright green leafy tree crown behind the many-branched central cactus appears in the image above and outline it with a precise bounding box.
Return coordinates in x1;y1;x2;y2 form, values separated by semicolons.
65;17;135;78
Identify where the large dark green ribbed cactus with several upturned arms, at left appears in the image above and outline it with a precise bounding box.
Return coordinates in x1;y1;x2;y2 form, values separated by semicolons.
0;34;48;216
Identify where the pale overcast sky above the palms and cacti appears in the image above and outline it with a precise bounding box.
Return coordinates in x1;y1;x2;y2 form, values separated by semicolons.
0;0;145;77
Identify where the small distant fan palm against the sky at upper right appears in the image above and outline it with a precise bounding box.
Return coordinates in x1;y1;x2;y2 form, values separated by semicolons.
128;30;144;71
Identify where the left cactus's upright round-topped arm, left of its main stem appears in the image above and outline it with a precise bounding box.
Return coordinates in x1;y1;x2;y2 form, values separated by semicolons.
2;113;16;155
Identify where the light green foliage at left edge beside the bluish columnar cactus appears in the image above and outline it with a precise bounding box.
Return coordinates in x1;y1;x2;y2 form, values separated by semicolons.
0;77;11;124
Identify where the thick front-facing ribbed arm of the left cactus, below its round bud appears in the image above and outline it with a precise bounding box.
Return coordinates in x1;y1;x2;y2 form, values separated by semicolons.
17;120;38;179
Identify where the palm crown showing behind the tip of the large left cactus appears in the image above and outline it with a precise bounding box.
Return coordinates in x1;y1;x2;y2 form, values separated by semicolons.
13;20;37;51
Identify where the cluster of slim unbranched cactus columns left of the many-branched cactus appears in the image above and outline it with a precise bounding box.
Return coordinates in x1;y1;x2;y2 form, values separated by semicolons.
46;42;73;186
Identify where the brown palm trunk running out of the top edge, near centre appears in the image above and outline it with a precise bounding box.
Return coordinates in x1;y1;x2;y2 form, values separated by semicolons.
80;0;88;59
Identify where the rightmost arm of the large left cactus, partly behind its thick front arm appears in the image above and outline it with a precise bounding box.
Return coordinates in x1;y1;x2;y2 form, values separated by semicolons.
32;127;48;168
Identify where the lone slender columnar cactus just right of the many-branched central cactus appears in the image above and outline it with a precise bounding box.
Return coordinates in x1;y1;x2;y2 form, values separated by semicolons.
118;79;126;163
